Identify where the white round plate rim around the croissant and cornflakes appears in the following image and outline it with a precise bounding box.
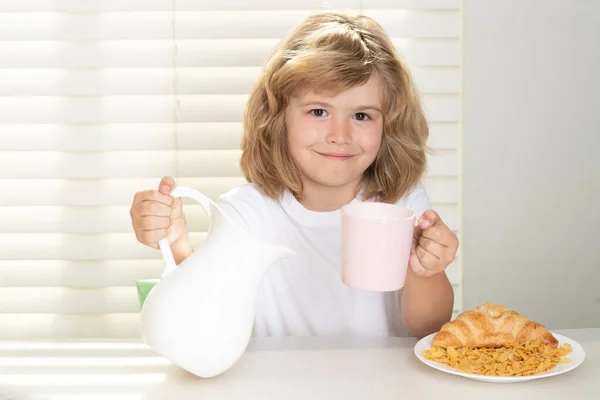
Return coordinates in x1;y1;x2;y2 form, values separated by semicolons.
415;333;585;383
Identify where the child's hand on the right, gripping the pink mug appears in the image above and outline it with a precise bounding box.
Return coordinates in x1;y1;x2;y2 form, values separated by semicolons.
409;210;458;277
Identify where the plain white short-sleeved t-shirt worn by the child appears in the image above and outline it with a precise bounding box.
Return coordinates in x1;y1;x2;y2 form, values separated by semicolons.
219;184;431;336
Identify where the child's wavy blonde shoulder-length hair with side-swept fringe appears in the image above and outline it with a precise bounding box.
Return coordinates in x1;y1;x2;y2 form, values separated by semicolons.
241;12;429;203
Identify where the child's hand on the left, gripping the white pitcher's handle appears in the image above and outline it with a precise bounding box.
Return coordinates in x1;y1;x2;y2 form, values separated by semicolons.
130;176;191;249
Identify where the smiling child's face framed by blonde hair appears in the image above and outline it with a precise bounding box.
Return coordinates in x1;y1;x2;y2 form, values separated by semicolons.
286;74;383;195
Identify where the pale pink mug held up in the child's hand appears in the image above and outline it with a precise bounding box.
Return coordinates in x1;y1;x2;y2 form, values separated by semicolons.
341;202;417;292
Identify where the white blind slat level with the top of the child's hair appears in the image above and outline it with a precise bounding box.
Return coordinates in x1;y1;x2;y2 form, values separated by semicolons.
0;9;460;41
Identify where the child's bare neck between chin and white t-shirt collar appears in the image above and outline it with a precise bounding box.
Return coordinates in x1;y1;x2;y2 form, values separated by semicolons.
298;182;360;212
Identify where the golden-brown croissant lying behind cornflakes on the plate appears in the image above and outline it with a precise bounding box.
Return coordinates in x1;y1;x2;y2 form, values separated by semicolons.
432;303;558;348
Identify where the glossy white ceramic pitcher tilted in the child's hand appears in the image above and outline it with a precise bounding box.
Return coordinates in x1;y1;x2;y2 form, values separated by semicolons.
141;187;295;378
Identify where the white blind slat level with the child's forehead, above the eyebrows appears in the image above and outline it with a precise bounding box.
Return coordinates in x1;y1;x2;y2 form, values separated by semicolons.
0;67;460;96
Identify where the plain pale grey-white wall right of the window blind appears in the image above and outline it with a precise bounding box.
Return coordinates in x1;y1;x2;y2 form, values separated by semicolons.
462;0;600;329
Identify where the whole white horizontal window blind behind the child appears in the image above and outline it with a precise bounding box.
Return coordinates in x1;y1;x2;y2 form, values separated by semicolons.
0;0;461;339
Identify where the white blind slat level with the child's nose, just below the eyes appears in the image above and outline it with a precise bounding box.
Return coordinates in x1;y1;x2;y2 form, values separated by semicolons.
0;122;458;151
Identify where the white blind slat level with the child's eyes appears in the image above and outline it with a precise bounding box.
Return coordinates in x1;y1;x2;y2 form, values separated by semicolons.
0;94;461;124
